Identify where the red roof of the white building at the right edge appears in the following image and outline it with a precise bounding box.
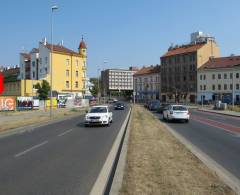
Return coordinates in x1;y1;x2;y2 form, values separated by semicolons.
200;56;240;69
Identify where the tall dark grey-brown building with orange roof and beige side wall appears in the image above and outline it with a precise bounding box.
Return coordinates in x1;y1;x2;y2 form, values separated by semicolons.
161;34;220;103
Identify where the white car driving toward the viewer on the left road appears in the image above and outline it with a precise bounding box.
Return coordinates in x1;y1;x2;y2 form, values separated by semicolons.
85;106;113;126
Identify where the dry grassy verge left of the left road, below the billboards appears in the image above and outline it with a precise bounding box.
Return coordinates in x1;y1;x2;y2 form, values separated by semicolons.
0;108;86;133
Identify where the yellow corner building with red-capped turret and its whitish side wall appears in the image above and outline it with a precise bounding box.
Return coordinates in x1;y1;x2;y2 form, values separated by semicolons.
38;39;87;97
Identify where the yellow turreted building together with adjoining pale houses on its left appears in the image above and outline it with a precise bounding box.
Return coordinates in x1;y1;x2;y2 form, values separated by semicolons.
20;39;87;97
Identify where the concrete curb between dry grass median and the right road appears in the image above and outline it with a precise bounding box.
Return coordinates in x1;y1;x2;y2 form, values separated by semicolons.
159;117;240;195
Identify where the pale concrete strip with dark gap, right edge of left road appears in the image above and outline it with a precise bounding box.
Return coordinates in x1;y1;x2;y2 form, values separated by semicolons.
90;108;132;195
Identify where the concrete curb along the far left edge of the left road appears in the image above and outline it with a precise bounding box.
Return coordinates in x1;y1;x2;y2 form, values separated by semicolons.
0;112;84;139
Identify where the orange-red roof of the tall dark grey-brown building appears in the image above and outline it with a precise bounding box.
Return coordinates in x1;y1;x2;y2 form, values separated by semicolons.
162;43;205;57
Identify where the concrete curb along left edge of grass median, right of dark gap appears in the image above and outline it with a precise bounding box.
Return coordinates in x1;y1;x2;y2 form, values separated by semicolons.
109;106;132;195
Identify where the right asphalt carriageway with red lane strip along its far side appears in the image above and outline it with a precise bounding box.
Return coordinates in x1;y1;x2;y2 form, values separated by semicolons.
156;110;240;179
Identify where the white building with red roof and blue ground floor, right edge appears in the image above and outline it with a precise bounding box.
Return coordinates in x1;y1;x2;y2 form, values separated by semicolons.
197;56;240;104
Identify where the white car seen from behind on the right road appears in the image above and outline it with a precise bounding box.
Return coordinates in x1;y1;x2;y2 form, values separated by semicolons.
163;105;190;122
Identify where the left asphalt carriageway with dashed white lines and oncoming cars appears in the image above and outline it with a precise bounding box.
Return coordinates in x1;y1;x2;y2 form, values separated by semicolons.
0;105;129;195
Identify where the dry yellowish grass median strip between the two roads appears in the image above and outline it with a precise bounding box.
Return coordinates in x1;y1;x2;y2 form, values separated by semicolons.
120;105;235;195
